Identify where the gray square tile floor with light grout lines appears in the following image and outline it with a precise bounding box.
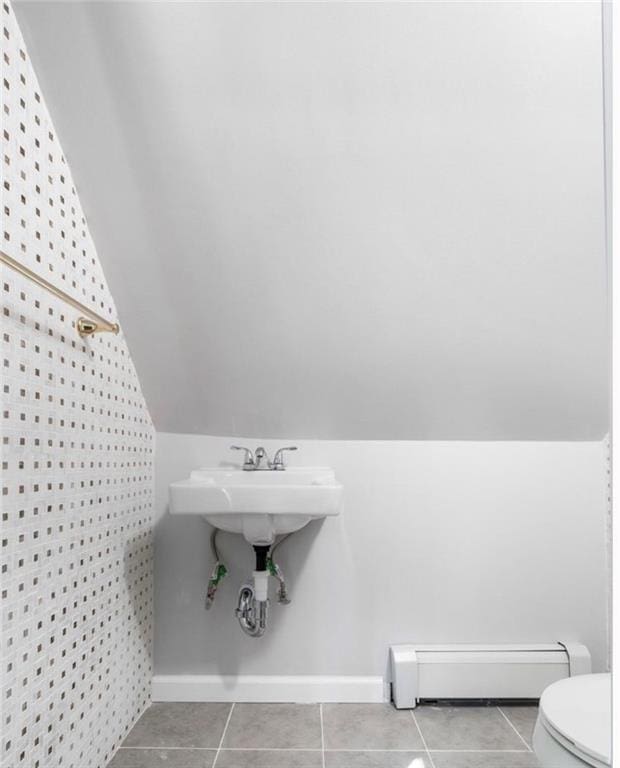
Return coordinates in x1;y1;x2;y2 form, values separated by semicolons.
108;703;538;768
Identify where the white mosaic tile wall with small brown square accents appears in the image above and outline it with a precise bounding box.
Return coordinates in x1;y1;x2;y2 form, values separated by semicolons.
0;4;154;768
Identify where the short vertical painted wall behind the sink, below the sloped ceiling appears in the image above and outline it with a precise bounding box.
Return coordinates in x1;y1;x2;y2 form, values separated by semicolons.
155;433;607;675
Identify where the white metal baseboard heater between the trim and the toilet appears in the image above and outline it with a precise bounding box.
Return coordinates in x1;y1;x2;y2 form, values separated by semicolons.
390;643;591;709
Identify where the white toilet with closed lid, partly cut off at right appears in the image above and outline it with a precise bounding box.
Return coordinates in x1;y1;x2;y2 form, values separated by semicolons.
533;674;611;768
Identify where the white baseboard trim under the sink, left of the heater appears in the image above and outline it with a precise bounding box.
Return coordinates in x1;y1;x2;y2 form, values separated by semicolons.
153;675;389;704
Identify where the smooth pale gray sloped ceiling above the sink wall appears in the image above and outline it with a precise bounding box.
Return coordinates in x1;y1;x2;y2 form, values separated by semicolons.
16;2;607;440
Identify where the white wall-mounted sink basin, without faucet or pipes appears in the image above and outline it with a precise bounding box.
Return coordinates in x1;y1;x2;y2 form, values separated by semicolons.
170;467;342;545
